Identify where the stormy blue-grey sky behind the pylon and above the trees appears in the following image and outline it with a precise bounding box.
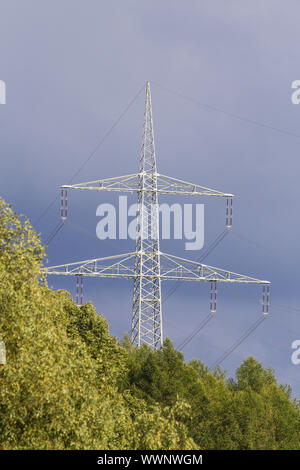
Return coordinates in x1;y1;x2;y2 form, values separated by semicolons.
0;0;300;393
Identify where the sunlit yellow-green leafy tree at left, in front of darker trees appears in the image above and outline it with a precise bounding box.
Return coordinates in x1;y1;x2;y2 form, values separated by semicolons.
0;200;196;449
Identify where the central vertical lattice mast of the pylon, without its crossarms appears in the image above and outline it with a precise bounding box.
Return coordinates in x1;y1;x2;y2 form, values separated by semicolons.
131;82;163;348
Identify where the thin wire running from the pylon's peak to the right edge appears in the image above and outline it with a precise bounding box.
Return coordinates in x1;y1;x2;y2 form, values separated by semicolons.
153;82;300;138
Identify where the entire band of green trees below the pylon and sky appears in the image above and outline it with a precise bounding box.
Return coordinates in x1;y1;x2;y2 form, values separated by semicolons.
0;199;300;450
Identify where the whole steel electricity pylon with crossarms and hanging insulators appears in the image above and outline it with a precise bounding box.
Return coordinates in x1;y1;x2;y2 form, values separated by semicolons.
45;82;270;349
